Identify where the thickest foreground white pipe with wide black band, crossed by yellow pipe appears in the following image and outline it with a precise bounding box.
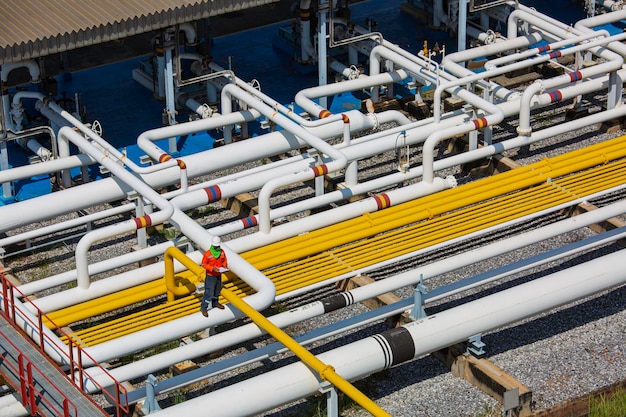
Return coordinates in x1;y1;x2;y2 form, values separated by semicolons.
153;247;626;417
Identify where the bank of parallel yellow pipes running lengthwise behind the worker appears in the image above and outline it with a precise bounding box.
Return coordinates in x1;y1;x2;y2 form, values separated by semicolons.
54;132;626;346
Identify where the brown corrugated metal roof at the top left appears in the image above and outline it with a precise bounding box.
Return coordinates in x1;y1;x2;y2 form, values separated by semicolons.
0;0;278;65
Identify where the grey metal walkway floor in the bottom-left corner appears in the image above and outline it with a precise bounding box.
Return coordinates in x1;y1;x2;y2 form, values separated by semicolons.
0;314;109;417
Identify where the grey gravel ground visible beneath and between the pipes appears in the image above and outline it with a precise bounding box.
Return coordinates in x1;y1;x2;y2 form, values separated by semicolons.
1;72;626;417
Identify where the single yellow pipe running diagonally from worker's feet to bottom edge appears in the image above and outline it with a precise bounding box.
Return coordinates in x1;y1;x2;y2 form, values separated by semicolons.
217;289;391;417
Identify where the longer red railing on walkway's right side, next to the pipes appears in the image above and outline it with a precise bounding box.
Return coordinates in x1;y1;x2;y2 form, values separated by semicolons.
0;273;129;417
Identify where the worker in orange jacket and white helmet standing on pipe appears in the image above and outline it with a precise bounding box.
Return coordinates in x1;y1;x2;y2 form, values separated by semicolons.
200;236;228;317
